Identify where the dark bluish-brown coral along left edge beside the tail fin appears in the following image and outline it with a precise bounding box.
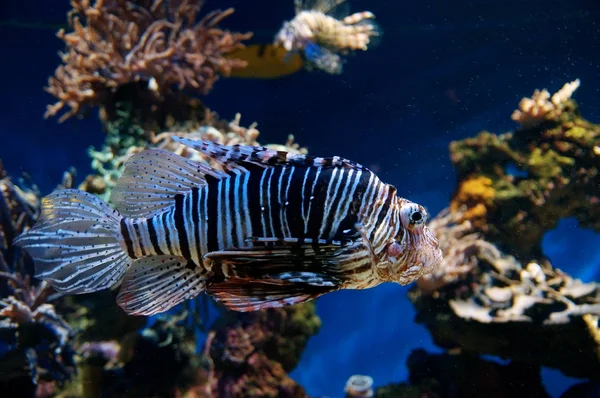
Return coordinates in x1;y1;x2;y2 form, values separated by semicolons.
0;166;74;396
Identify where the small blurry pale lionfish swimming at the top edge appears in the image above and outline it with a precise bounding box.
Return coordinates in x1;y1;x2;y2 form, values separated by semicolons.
275;0;381;74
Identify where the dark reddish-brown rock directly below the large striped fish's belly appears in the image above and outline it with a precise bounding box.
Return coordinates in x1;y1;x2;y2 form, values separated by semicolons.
207;303;321;398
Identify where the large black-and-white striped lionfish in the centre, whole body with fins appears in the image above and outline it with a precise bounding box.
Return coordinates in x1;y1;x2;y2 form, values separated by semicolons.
15;137;442;315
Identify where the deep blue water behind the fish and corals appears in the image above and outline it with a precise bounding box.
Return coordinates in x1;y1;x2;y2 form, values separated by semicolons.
0;0;600;397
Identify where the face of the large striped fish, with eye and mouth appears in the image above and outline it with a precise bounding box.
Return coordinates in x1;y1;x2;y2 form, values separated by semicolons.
380;198;443;285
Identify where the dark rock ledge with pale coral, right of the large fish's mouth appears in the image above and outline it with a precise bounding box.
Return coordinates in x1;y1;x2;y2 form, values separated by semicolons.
409;208;600;377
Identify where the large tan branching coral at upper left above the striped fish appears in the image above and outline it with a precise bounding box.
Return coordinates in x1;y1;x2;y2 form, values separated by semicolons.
45;0;252;122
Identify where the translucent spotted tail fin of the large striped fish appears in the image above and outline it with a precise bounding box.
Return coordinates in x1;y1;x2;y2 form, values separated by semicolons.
14;189;133;294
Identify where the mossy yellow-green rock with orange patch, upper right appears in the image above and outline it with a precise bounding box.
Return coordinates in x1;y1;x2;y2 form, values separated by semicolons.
450;80;600;262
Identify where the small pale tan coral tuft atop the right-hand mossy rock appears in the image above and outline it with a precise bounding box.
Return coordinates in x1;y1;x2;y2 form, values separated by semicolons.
511;79;580;128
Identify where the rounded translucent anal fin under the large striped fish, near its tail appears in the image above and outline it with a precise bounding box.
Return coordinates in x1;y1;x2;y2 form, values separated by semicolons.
117;256;206;315
